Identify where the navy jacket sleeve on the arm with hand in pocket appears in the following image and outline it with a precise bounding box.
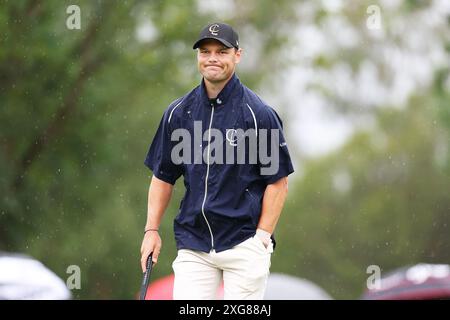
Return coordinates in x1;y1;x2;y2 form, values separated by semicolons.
258;107;294;184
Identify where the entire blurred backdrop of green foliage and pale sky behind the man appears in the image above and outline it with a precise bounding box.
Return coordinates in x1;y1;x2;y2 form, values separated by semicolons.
0;0;450;299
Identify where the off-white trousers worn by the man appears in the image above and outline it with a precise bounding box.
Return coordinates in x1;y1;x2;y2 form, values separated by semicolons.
172;236;273;300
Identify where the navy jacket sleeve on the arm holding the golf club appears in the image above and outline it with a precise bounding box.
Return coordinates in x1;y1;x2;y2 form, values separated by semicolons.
144;108;183;185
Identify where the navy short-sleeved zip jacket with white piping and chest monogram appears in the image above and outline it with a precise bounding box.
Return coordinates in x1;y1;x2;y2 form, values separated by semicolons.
145;75;294;252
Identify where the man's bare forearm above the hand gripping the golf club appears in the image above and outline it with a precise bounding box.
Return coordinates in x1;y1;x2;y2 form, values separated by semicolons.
145;176;173;229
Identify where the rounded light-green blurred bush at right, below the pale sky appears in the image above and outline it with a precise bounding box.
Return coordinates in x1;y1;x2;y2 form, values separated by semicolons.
273;92;450;299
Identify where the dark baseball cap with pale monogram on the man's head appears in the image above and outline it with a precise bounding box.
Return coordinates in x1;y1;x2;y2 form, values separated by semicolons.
193;22;239;49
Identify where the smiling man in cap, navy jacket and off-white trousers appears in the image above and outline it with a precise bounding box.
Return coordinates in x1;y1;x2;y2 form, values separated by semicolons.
141;23;294;299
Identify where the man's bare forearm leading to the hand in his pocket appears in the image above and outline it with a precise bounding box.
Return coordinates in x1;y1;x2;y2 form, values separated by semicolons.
258;177;288;234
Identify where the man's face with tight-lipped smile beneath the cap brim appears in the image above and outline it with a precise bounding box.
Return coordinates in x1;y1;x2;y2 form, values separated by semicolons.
197;39;241;83
